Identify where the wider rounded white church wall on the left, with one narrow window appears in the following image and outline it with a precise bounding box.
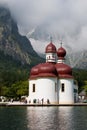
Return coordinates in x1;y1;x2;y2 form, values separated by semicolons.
29;77;57;103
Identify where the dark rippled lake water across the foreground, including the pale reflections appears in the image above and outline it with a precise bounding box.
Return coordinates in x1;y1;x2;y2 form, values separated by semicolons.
0;106;87;130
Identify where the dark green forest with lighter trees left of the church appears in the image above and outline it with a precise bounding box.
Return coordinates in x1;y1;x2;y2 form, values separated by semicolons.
0;53;30;99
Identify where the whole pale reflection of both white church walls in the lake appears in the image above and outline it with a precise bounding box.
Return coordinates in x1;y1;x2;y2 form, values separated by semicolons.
27;107;72;130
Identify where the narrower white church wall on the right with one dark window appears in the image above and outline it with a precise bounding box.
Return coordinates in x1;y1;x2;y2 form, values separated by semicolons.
58;79;74;104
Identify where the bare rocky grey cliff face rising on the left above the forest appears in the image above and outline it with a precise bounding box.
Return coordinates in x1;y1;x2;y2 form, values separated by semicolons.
0;8;42;65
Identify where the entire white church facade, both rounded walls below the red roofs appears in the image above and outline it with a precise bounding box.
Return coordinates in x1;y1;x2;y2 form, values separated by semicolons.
28;77;78;104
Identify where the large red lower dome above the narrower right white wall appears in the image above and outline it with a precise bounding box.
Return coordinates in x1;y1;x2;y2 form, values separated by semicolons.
55;63;73;78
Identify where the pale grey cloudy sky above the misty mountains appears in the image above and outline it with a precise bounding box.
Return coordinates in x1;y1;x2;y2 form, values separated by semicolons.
0;0;87;50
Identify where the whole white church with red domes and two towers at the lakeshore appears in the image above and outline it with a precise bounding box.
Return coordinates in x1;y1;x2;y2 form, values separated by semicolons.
28;41;78;104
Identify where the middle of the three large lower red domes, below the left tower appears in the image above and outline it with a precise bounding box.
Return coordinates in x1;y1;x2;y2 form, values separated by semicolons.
39;63;57;77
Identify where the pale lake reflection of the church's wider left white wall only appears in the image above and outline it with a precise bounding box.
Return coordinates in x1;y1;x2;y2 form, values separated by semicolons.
27;107;57;130
